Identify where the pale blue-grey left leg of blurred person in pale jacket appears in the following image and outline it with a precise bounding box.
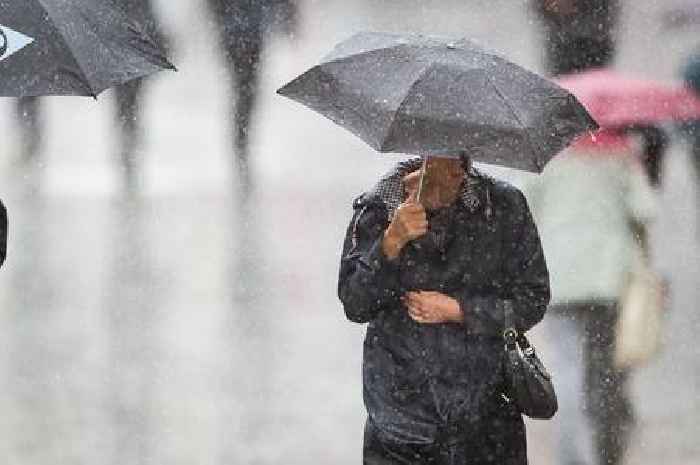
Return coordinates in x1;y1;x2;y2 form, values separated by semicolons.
542;306;594;465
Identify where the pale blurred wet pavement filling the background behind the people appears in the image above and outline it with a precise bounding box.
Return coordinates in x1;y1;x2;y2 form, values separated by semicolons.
0;0;700;465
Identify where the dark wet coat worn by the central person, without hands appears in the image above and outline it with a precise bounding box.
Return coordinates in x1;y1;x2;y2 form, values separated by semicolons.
338;160;549;464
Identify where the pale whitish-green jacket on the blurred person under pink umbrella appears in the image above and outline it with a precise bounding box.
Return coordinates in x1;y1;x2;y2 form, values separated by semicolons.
526;149;656;305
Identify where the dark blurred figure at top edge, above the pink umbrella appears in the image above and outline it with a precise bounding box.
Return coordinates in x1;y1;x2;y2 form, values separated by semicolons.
532;0;620;76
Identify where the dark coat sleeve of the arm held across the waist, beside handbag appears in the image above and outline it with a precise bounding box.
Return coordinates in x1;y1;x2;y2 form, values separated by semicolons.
453;191;550;335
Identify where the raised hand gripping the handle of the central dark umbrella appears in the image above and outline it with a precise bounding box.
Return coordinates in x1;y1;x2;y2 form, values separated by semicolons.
382;189;428;259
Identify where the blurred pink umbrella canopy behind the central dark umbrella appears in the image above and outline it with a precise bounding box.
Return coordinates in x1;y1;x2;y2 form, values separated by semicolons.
556;69;700;128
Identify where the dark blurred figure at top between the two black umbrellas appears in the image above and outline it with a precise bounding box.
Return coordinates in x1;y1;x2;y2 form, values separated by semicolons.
207;0;298;199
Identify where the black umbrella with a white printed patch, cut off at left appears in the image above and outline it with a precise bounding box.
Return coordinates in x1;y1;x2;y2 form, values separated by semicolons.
0;0;174;97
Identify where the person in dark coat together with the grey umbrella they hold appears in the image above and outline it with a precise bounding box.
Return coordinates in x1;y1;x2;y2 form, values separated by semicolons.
278;33;596;465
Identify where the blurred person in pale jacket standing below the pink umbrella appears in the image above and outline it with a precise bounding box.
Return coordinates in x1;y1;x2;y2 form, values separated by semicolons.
528;130;656;465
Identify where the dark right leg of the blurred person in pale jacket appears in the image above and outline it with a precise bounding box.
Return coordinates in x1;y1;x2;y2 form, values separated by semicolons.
584;305;633;465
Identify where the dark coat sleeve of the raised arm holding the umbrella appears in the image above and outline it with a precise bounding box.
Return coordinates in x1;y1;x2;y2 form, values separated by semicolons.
338;201;400;323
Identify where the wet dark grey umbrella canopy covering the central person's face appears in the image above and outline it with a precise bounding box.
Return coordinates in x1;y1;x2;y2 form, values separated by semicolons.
278;32;597;172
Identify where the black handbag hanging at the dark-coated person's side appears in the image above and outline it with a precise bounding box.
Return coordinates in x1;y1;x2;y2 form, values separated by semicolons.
503;302;559;420
